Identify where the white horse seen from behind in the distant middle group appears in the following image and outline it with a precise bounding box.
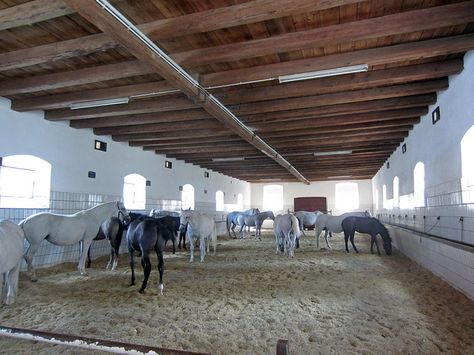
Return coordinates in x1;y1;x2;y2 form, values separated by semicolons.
273;214;300;258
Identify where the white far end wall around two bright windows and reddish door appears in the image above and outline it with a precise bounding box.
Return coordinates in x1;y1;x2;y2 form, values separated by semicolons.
251;180;372;215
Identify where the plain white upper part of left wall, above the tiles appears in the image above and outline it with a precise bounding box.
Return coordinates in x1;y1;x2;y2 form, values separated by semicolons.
0;98;250;209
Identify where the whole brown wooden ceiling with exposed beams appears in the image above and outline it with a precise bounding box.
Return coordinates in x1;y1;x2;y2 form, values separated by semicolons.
0;0;474;182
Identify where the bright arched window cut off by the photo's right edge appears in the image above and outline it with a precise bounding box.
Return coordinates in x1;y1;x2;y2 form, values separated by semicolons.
461;126;474;203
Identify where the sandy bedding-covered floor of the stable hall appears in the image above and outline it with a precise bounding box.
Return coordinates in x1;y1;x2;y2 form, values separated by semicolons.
0;230;474;355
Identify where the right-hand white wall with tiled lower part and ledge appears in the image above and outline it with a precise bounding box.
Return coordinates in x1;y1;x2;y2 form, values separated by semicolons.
372;51;474;299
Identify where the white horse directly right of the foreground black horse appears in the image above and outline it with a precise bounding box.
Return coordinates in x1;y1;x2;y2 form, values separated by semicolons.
180;211;217;263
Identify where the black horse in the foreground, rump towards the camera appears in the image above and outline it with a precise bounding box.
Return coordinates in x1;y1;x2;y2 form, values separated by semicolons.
127;218;174;294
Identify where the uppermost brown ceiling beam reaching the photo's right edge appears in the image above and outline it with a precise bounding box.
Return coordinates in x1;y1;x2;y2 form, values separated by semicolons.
171;1;474;68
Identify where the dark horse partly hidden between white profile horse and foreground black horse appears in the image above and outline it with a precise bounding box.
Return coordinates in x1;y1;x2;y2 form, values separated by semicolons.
87;217;125;270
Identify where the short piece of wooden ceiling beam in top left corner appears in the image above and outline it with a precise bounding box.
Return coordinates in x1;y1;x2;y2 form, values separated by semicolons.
0;0;73;31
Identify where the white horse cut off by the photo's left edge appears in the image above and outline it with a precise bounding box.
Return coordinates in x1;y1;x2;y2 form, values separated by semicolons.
0;220;25;305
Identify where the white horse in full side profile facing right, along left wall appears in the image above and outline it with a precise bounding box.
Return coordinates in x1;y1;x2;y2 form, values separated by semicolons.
20;201;129;281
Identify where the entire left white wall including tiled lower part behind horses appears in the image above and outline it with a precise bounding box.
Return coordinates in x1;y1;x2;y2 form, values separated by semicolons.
0;98;250;266
